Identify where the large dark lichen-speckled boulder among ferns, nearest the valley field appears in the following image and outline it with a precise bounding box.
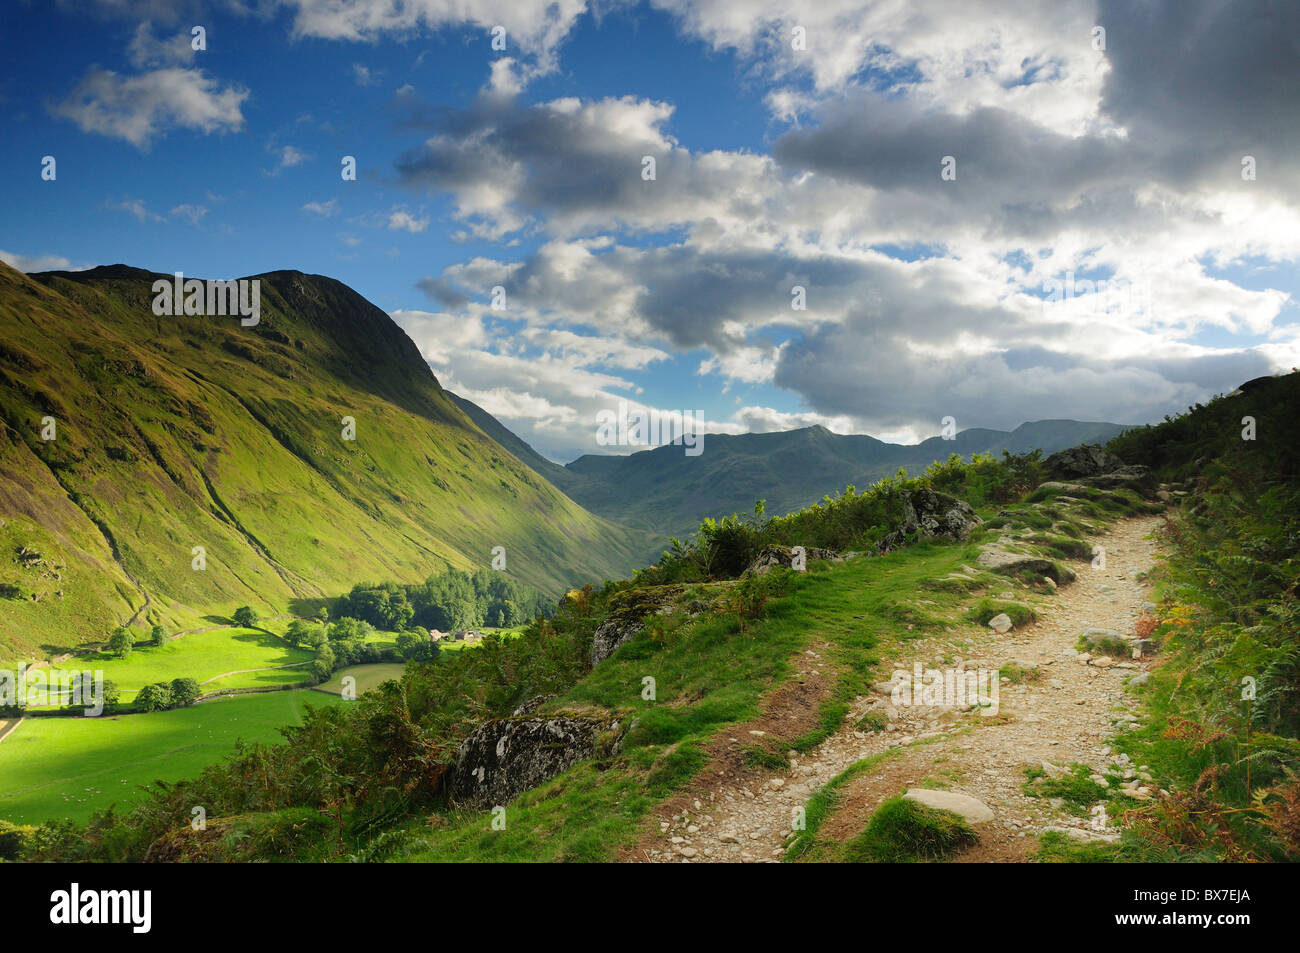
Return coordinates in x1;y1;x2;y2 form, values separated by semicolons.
449;697;625;807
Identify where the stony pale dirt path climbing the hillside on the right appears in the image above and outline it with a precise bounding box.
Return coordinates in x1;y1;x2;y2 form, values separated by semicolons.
634;516;1161;862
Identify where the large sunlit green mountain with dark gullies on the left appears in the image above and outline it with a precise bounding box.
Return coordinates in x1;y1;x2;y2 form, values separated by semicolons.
0;264;650;658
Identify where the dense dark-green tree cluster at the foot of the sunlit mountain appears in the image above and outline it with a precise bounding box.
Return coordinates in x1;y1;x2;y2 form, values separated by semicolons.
334;569;554;632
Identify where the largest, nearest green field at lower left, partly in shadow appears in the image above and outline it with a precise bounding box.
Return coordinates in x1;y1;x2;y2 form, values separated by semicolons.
0;689;338;824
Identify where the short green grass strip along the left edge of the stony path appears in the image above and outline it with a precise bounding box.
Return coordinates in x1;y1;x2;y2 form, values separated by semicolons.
379;545;974;861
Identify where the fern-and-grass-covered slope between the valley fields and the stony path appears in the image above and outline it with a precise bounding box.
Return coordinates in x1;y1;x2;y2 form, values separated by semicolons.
7;449;1170;861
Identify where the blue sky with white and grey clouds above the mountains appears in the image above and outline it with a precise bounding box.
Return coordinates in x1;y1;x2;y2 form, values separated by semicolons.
0;0;1300;462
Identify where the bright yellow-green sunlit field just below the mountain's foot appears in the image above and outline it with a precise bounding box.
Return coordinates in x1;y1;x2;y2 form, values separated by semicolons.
38;628;312;702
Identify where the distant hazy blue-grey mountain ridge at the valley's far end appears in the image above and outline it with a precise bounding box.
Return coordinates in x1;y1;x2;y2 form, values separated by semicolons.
451;395;1126;540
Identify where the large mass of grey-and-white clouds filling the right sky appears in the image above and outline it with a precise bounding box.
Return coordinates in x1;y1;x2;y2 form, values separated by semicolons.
382;0;1300;449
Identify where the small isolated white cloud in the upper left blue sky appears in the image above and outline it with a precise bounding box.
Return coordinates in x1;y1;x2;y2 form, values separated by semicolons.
52;66;248;150
